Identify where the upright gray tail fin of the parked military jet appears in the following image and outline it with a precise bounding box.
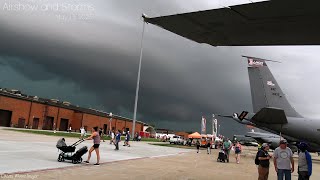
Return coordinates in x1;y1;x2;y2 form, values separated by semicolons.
243;56;302;117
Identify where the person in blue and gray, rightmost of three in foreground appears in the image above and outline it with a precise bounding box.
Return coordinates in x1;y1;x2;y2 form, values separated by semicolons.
298;143;312;180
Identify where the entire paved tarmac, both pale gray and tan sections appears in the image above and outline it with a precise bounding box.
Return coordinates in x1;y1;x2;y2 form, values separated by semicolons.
0;129;320;180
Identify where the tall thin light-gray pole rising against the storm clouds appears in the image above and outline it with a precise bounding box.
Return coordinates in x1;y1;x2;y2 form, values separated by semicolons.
131;16;146;137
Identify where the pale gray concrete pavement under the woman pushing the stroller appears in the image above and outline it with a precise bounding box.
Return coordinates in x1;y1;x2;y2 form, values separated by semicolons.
0;128;190;175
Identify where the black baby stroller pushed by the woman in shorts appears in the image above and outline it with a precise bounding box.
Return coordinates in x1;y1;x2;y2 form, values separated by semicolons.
56;138;88;164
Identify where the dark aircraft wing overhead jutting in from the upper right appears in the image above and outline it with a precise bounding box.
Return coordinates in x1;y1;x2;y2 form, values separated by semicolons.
144;0;320;46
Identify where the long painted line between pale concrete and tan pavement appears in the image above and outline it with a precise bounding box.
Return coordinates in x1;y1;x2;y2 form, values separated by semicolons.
0;152;188;177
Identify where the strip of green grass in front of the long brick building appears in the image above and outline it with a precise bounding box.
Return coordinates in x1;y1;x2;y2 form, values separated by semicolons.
4;129;159;142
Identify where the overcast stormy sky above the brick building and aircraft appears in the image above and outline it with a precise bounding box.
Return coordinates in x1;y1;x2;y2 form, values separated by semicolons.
0;0;320;136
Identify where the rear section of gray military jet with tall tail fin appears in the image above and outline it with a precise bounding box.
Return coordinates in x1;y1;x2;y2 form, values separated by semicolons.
220;56;320;152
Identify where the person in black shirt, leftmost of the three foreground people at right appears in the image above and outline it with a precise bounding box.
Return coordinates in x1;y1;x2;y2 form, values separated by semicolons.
258;143;272;180
